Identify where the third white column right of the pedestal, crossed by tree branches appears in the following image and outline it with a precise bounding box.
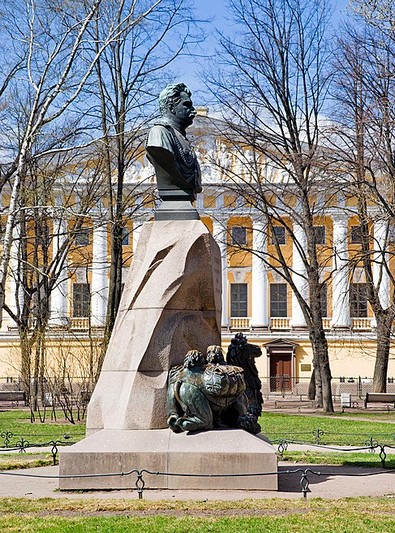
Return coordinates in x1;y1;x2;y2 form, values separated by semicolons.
291;223;309;328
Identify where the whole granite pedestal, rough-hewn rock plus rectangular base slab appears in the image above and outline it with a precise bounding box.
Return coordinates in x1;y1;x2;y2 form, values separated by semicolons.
60;220;277;490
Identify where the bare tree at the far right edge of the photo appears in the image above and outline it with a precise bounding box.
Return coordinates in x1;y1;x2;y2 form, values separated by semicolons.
333;26;395;392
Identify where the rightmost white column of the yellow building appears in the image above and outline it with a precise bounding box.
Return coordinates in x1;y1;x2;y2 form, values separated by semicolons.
373;220;391;309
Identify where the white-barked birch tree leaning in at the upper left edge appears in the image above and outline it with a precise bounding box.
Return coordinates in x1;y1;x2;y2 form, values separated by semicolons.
0;0;161;323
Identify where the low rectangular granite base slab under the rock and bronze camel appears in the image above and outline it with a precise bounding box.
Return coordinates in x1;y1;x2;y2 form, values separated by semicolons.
59;429;277;490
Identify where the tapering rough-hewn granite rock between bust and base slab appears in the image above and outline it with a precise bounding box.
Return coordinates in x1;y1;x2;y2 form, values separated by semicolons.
87;220;221;435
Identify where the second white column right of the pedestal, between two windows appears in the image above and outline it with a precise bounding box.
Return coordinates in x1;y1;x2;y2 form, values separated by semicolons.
250;220;269;328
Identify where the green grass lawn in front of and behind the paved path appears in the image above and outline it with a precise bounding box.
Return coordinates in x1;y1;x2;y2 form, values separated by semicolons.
0;410;395;533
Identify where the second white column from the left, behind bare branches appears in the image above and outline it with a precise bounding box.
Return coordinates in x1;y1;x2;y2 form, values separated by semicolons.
49;218;69;326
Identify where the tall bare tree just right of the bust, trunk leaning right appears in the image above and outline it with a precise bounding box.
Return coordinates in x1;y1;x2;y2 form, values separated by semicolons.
211;0;333;412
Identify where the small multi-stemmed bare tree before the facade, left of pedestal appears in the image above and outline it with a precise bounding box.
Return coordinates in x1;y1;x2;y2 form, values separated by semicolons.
4;150;108;412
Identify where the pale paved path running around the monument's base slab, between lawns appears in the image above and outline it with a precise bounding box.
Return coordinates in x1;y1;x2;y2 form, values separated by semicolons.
0;462;395;500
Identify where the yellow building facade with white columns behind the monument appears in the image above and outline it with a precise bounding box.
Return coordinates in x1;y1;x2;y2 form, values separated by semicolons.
0;116;395;395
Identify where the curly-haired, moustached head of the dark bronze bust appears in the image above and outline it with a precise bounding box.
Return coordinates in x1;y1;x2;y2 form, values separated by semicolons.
159;83;196;128
